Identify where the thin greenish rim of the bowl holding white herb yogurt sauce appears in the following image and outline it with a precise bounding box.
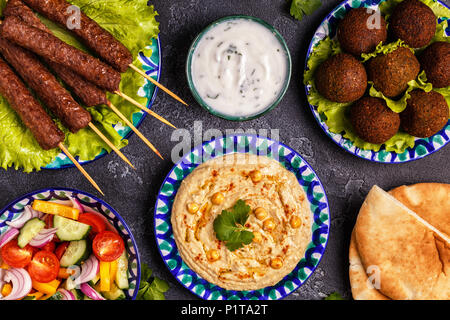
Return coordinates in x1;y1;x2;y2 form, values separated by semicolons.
185;15;292;122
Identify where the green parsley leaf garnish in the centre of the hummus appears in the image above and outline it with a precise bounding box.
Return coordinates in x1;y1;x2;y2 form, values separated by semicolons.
214;200;253;251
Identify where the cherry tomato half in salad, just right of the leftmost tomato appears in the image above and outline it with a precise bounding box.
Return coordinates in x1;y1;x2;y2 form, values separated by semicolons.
28;251;59;283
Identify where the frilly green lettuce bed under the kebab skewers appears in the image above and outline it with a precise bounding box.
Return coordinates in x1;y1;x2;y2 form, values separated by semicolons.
0;0;159;172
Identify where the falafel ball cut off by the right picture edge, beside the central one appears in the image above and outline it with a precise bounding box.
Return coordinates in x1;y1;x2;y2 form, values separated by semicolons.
419;41;450;88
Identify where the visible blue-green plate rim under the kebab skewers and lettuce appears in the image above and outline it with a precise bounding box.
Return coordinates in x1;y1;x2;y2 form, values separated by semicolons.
42;35;162;170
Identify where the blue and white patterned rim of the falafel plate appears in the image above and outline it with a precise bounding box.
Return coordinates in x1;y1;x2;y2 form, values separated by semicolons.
304;0;450;164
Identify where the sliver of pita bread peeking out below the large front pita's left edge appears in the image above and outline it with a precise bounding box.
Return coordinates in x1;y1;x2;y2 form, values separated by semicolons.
349;232;391;300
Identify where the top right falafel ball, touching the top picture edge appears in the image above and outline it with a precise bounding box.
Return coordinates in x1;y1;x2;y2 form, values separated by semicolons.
389;0;437;48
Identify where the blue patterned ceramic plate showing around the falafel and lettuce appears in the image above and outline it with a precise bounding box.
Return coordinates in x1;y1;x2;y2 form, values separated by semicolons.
305;0;450;163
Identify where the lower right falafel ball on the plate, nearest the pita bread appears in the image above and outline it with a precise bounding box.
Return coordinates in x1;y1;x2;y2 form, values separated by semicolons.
400;90;449;138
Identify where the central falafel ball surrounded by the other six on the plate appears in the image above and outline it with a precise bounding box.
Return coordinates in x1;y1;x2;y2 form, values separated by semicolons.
367;47;420;98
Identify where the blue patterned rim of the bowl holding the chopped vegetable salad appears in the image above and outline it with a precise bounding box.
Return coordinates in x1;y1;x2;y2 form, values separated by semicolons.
0;188;141;300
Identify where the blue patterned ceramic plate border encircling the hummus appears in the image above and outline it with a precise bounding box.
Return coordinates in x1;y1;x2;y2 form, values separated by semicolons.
155;135;330;300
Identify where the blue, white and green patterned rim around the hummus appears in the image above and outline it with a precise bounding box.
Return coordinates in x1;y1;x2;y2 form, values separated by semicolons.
154;134;331;300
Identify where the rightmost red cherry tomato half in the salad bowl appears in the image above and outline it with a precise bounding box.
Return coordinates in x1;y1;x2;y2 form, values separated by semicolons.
92;231;125;262
